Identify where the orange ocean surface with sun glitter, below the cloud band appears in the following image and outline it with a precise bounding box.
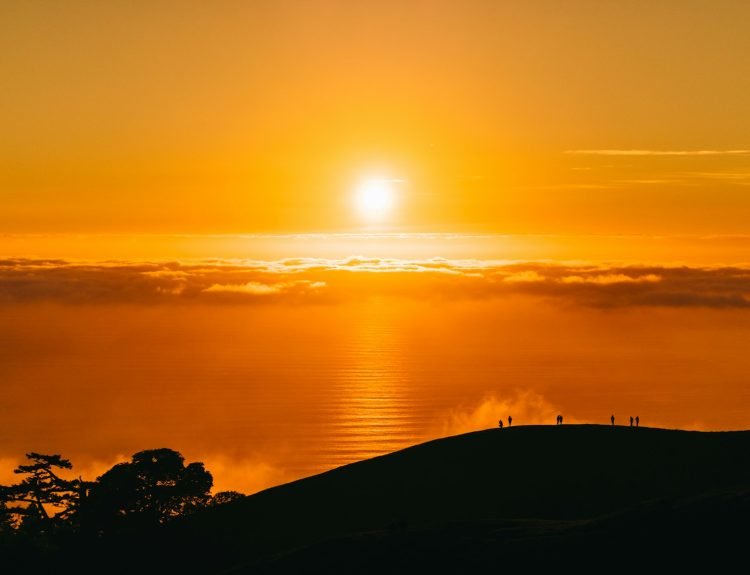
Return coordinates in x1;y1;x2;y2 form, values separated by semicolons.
0;296;750;491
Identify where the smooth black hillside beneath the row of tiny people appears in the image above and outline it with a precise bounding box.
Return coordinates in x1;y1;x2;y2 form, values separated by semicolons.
171;425;750;573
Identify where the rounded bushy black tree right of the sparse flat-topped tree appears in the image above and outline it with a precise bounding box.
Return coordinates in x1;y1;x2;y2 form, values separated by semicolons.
82;448;213;533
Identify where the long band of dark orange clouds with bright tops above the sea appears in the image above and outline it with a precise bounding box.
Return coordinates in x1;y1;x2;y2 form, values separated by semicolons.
0;257;750;308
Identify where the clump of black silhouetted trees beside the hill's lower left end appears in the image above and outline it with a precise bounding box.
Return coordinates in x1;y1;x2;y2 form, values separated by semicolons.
0;448;232;555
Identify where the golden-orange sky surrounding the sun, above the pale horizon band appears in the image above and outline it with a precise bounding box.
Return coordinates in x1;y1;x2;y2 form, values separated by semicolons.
0;0;750;234
